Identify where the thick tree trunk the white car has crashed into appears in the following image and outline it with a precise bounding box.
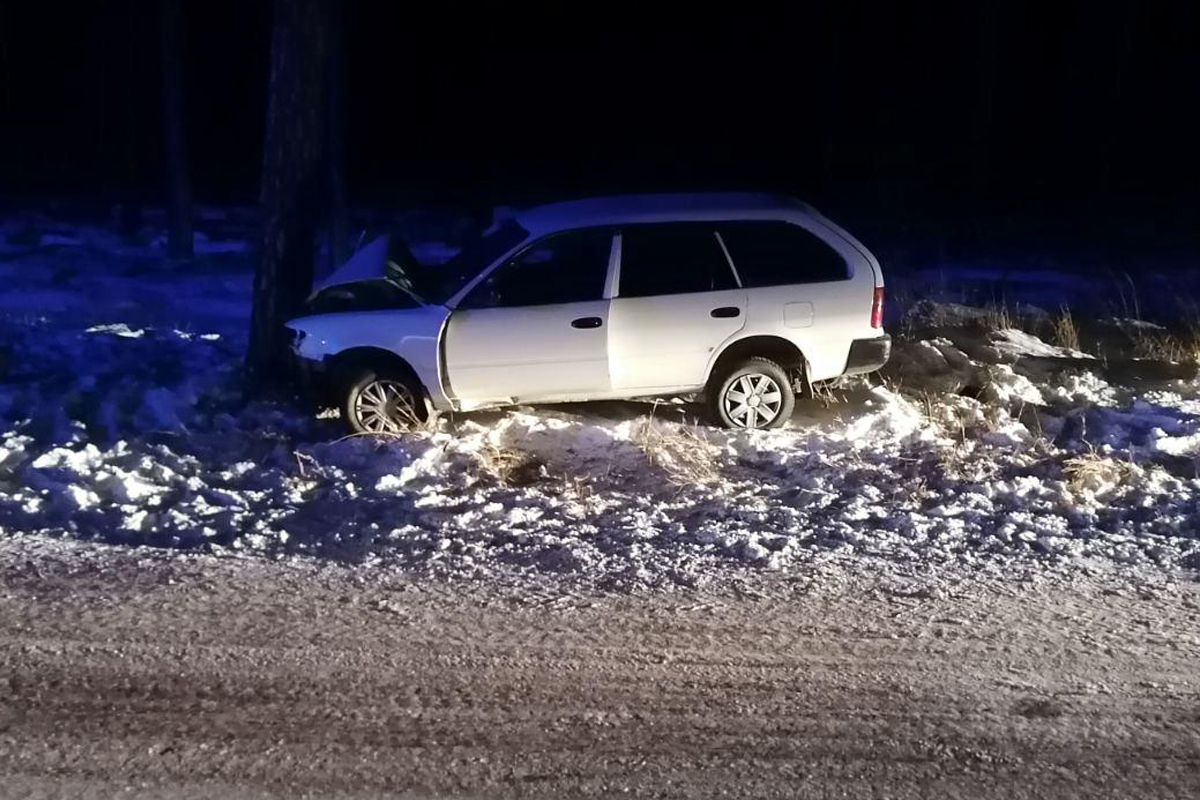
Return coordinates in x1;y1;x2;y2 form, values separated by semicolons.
246;0;331;385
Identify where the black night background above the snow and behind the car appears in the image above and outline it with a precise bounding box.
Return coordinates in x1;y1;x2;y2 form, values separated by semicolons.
0;0;1200;263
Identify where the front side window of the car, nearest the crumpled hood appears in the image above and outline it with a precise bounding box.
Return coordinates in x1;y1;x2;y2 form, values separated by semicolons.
462;230;612;308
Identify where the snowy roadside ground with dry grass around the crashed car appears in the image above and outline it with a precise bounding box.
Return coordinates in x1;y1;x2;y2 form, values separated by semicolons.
0;211;1200;588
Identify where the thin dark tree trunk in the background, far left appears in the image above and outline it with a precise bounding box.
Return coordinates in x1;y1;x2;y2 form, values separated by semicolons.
158;0;192;260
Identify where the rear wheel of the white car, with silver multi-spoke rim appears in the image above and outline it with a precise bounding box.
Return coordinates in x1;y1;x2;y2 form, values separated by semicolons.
708;356;796;429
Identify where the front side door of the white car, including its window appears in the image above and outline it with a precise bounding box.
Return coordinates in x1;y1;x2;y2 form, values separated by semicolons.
445;230;613;407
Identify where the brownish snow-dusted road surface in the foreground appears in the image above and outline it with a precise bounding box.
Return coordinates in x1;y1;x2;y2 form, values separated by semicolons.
0;545;1200;798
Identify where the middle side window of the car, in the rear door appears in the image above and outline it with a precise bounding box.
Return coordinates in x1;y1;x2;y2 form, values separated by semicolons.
617;223;737;297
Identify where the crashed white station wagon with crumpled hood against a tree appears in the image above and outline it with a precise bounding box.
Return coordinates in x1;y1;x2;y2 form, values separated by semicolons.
288;194;892;432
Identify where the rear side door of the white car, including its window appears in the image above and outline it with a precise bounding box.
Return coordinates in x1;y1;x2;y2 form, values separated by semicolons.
608;222;746;392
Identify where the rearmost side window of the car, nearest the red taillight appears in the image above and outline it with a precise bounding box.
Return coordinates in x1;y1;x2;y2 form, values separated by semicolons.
719;221;850;288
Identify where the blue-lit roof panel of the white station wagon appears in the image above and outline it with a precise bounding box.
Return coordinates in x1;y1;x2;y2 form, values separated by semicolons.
516;192;821;235
